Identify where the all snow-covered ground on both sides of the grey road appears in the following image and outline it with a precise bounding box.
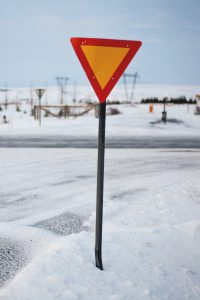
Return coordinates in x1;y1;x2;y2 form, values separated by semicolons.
0;84;200;300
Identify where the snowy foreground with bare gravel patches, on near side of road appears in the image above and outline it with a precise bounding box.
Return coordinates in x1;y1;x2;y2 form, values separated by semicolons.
0;149;200;300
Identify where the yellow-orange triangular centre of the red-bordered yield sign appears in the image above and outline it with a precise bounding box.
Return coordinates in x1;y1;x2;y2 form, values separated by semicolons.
81;45;130;89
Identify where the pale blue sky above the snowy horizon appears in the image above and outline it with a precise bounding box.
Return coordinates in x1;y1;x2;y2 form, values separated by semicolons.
0;0;200;86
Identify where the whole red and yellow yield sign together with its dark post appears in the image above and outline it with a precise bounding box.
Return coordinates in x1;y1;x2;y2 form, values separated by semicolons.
71;38;142;270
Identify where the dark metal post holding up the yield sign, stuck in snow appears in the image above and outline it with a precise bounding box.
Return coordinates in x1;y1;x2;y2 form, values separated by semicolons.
95;102;106;270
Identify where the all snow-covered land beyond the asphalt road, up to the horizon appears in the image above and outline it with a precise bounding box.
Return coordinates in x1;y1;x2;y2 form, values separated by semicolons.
0;84;200;137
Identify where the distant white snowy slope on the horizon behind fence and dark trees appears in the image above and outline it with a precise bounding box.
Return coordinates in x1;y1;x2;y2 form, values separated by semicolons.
0;82;200;104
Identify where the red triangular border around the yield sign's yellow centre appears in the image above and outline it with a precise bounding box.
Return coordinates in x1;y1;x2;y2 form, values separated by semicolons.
70;37;142;103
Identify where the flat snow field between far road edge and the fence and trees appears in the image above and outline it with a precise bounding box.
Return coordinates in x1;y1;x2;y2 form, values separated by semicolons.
0;104;200;137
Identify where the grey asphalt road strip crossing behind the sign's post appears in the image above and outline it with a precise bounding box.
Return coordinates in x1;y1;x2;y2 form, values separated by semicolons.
0;136;200;149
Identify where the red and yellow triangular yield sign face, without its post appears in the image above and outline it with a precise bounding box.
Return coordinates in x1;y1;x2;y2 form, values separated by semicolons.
71;38;142;103
